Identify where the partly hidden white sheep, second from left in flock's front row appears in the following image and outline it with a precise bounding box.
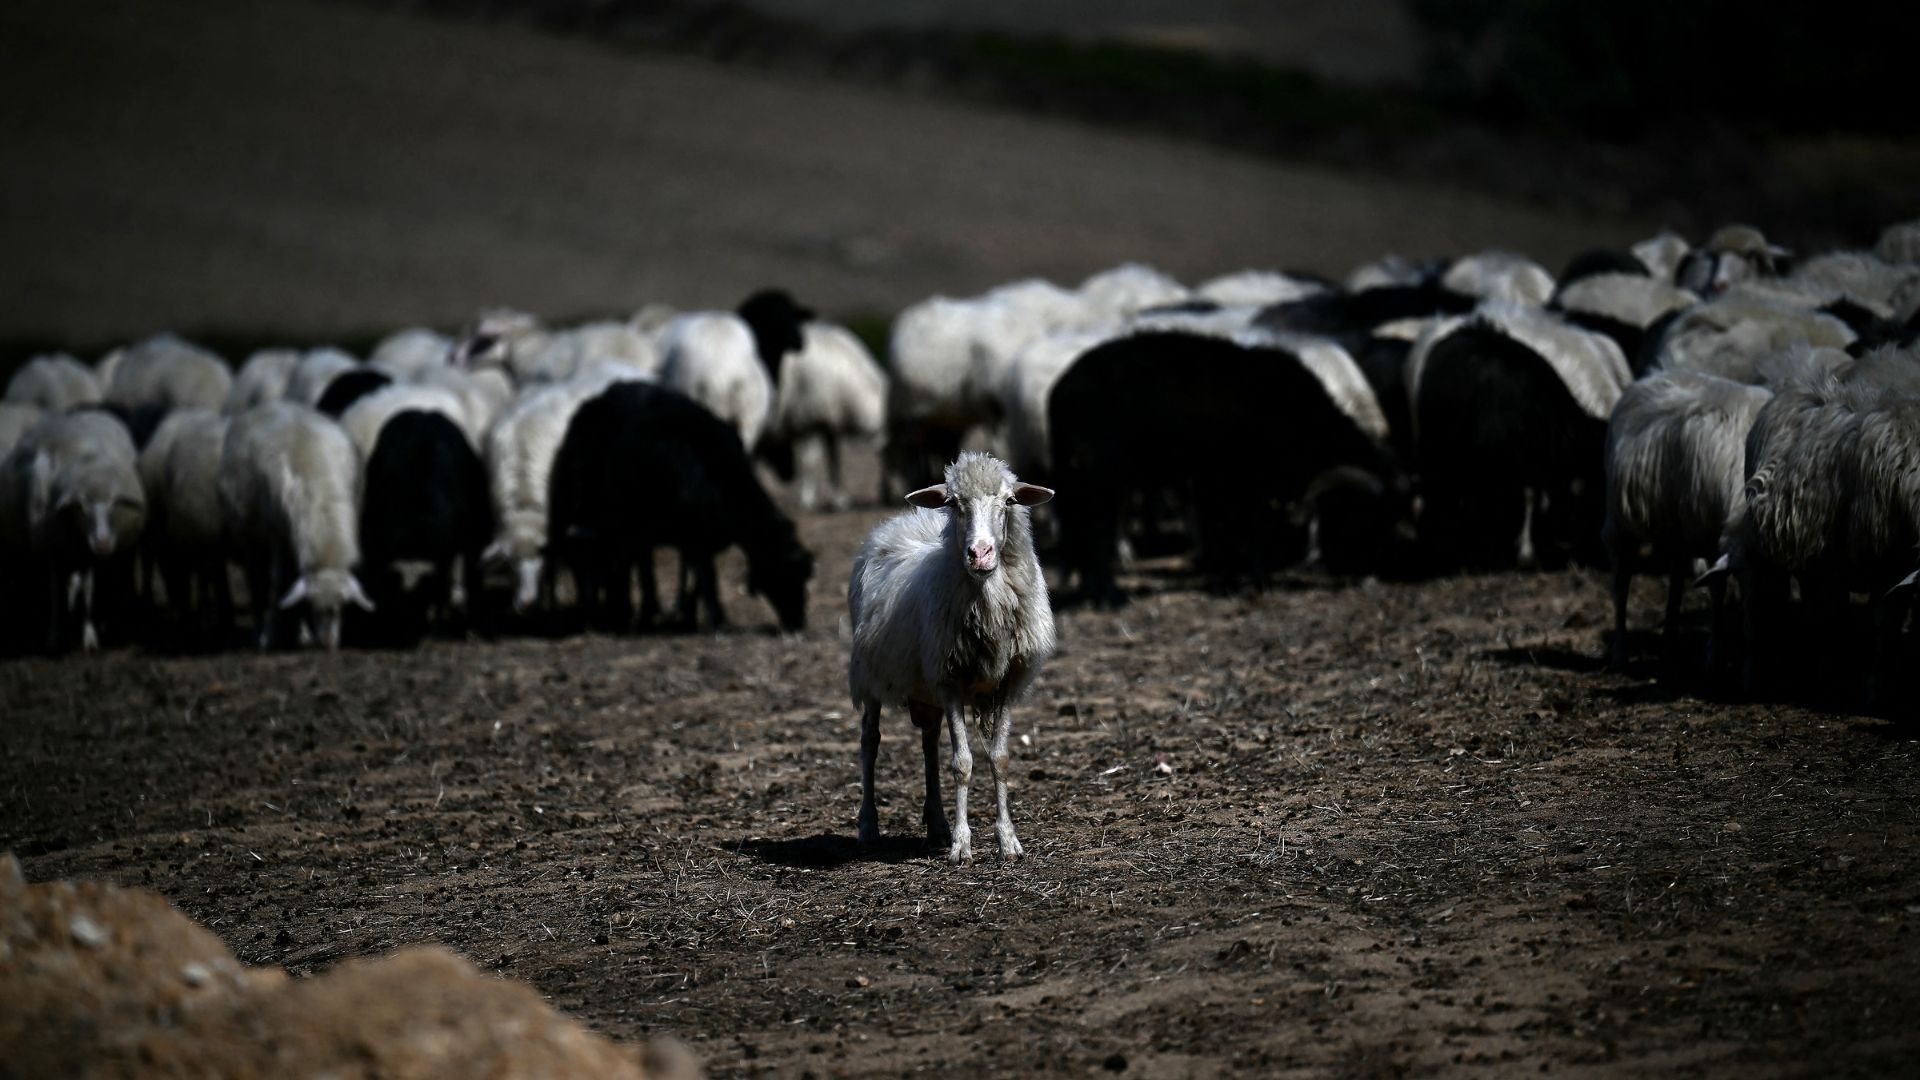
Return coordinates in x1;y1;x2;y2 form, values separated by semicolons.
140;409;232;628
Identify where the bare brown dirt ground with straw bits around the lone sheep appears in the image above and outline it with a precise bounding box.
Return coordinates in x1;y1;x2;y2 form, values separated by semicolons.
0;443;1920;1076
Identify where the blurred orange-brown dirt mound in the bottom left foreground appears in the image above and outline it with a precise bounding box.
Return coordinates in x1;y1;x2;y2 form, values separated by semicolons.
0;855;699;1080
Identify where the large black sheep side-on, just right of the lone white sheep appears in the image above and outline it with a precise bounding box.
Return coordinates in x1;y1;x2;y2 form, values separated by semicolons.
1046;332;1398;605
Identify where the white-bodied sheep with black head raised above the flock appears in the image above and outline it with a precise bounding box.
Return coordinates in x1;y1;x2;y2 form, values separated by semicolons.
659;292;794;452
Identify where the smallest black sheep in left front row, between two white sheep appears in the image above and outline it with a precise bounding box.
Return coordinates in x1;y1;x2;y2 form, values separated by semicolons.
359;409;493;644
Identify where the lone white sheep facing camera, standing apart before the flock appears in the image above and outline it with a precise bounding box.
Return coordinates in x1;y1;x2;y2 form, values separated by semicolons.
847;454;1054;865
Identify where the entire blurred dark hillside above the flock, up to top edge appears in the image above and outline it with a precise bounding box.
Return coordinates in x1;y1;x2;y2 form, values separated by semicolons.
0;0;1920;367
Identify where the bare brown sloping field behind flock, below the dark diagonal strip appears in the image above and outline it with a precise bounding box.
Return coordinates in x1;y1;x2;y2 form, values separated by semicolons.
0;0;1657;344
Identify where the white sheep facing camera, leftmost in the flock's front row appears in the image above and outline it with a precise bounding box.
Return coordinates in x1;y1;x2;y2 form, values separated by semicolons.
4;411;146;651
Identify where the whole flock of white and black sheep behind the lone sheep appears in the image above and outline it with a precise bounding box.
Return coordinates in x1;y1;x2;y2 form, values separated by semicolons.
0;215;1920;711
